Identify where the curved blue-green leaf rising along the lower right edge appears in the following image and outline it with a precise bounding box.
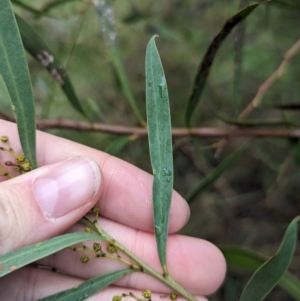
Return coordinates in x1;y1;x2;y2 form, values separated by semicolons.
240;216;300;301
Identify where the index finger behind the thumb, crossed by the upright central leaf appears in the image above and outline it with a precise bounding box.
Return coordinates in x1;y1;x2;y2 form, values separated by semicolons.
0;121;189;233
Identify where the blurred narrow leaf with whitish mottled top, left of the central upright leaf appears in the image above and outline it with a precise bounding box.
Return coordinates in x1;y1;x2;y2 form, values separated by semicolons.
93;0;146;126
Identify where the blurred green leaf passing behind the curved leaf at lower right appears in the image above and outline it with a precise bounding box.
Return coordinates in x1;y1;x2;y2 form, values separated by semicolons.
219;246;300;301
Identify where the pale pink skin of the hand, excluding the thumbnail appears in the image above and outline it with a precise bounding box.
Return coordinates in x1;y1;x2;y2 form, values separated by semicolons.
0;121;226;301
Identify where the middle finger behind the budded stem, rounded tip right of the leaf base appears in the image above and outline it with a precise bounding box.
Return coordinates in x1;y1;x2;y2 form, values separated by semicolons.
40;219;226;295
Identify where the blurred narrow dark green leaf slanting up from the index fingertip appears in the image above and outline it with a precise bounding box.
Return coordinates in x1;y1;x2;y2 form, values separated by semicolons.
185;142;250;202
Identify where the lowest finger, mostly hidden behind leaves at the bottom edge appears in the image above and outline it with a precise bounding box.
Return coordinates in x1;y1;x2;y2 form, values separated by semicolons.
0;267;207;301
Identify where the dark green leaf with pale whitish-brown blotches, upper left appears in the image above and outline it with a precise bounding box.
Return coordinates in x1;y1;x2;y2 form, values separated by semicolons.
16;15;90;120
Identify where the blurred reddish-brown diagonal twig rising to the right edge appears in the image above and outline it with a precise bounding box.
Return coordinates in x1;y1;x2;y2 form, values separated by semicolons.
216;35;300;156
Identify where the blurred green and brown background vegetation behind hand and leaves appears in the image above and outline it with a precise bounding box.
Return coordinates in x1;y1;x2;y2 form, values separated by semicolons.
0;0;300;301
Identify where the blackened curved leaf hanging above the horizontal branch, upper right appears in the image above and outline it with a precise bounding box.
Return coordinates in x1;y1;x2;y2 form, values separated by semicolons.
185;1;268;127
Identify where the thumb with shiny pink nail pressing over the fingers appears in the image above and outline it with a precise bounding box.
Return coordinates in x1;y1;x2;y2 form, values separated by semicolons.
0;157;103;255
